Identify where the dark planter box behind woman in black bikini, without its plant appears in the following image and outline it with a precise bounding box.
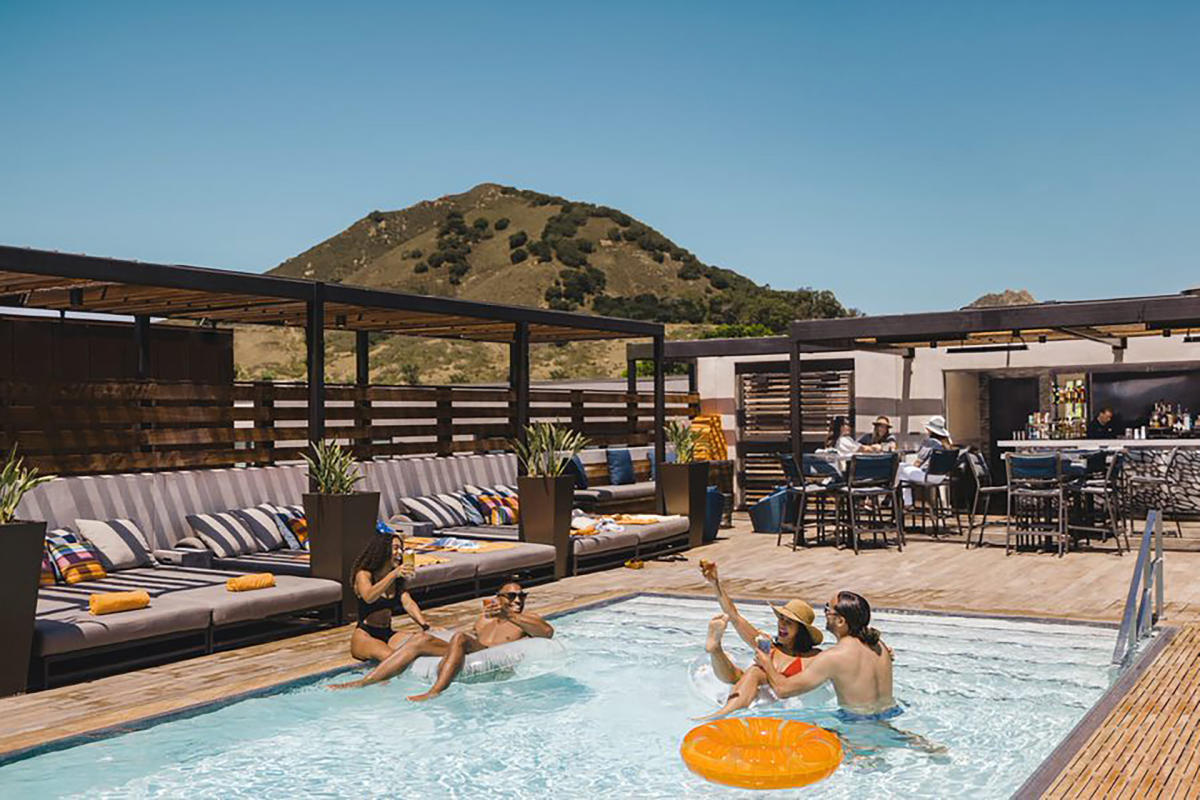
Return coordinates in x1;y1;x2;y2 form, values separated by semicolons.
304;492;379;619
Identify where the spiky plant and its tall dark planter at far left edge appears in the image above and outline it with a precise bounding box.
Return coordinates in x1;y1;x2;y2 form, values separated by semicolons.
0;445;54;697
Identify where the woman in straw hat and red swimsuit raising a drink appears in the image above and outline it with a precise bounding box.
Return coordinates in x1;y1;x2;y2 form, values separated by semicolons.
700;560;824;720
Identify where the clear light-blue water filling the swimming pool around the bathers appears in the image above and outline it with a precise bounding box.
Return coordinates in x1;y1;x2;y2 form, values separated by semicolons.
0;593;1116;800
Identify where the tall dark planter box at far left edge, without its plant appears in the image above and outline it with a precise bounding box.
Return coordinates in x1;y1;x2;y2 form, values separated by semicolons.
0;522;46;697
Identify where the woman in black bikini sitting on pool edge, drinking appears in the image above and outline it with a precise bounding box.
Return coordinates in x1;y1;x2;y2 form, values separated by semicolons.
350;536;430;661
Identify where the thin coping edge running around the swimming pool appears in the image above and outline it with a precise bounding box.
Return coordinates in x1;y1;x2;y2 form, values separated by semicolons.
0;590;1178;772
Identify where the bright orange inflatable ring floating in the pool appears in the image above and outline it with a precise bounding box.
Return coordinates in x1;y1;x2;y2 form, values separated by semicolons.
679;717;841;789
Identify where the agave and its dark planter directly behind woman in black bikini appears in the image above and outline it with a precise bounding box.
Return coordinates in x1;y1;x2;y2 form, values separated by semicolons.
304;441;379;616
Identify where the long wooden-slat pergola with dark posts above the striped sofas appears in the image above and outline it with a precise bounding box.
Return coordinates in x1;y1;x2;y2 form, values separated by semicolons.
0;246;666;462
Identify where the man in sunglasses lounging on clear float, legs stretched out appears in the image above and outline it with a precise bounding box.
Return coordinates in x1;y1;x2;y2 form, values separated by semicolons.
334;581;554;700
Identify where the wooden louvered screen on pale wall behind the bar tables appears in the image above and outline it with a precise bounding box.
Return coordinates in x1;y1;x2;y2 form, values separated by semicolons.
737;359;854;507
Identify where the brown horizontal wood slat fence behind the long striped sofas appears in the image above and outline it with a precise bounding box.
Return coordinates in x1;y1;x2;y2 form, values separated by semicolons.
0;380;700;475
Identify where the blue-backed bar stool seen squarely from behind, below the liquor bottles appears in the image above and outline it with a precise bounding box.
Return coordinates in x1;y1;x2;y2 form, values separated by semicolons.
1004;453;1067;558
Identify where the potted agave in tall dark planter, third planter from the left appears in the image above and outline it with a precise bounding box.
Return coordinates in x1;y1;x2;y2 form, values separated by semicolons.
512;422;588;578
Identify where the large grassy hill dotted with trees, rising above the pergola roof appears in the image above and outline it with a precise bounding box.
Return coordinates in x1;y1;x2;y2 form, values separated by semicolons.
271;184;850;333
